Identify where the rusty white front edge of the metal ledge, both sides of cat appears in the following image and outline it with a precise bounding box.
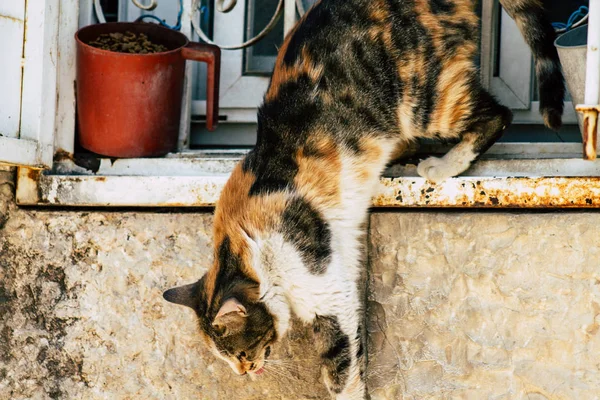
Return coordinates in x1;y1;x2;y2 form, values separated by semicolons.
17;168;600;209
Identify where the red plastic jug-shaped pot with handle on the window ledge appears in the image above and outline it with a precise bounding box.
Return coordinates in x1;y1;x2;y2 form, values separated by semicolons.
75;22;221;157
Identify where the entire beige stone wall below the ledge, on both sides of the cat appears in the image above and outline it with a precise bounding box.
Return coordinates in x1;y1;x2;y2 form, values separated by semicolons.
0;172;600;400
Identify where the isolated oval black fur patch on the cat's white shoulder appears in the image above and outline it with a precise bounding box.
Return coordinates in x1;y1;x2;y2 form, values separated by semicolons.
283;198;331;275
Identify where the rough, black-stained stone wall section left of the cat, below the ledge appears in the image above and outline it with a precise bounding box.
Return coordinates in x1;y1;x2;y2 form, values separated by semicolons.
0;170;326;400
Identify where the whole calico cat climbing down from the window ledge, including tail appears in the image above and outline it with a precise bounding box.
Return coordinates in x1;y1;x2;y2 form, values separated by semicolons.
164;0;564;400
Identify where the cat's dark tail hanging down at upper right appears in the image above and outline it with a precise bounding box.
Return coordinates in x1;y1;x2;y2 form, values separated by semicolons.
500;0;565;130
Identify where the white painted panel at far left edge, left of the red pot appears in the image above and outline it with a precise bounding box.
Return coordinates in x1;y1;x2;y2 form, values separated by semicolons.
0;0;59;168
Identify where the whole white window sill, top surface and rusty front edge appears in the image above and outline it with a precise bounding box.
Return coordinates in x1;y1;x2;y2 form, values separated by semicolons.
17;145;600;209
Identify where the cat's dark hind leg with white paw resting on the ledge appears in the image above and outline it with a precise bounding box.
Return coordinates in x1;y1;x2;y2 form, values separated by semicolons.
417;89;512;183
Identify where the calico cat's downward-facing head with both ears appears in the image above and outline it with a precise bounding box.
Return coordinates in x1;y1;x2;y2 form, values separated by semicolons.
163;238;279;375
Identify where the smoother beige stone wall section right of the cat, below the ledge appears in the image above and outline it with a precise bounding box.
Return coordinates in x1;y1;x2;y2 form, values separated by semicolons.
369;212;600;400
